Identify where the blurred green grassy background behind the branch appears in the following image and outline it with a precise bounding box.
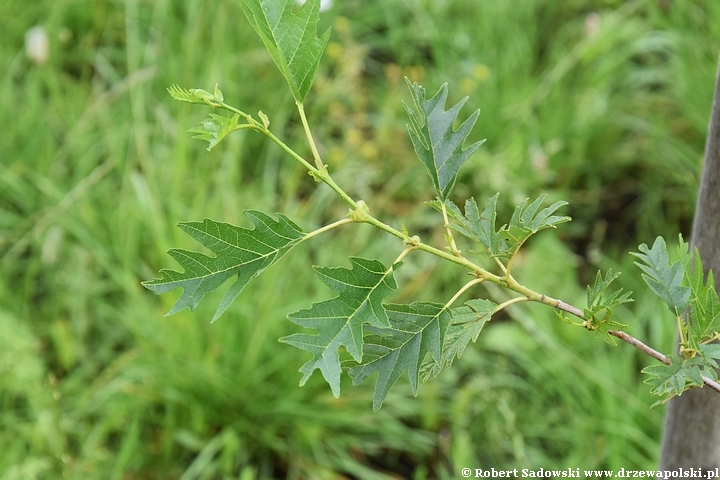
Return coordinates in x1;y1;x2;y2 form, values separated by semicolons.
0;0;720;480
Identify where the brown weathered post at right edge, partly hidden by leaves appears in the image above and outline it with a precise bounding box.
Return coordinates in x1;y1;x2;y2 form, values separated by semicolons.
660;60;720;470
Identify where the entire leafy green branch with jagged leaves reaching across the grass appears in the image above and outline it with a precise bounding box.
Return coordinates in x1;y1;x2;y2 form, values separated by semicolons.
146;0;720;410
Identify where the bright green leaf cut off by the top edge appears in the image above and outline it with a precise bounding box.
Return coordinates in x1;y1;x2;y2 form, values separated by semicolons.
240;0;330;103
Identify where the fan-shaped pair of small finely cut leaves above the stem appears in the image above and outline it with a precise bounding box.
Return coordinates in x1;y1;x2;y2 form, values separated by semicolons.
430;194;571;257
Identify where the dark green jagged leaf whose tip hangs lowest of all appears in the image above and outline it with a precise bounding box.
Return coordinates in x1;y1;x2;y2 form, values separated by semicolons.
349;303;451;411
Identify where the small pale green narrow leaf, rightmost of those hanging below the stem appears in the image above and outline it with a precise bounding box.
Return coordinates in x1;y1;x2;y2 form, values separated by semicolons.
422;299;497;381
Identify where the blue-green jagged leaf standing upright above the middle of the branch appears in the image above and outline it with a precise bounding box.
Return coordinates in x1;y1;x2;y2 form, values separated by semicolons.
405;78;484;201
